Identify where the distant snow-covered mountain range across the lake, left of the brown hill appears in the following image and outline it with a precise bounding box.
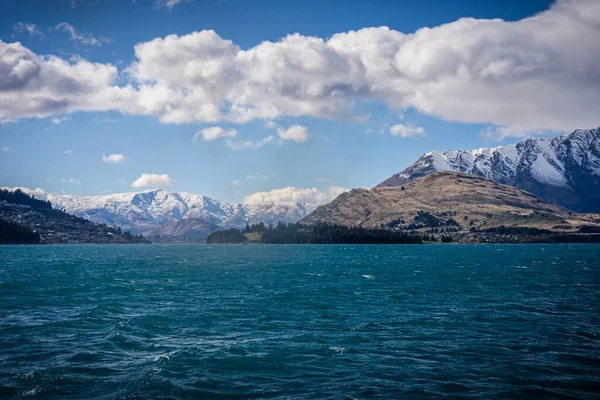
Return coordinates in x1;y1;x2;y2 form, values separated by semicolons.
4;188;316;236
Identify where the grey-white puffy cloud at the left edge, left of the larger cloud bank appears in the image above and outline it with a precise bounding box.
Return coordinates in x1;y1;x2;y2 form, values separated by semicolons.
0;40;135;121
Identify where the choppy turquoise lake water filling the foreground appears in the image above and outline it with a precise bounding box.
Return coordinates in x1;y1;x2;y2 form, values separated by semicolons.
0;244;600;399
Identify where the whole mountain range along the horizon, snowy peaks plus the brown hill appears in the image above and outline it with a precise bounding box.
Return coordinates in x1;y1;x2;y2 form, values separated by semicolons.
5;129;600;240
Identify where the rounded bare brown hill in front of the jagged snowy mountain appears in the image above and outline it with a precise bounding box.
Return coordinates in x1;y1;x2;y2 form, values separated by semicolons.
301;172;600;231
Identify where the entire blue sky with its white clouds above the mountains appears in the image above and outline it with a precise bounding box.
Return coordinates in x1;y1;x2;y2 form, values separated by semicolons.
0;0;600;202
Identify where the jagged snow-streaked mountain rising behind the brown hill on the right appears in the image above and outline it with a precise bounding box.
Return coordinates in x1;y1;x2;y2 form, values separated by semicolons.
377;128;600;212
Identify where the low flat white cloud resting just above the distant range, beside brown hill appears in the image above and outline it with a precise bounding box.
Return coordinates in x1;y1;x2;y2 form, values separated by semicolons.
244;186;348;204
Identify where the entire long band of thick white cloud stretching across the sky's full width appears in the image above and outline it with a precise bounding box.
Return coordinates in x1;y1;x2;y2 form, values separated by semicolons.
0;0;600;131
